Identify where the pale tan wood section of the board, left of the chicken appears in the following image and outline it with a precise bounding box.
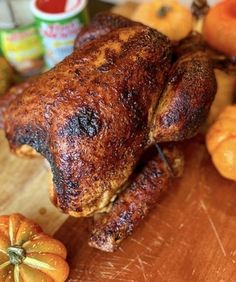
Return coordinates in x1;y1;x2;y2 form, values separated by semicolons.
0;130;67;234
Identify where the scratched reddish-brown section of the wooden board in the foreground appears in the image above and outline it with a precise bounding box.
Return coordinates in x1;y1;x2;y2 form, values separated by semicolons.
56;136;236;282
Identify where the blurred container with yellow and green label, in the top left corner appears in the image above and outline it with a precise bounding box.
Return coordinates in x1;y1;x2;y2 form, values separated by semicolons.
0;0;44;76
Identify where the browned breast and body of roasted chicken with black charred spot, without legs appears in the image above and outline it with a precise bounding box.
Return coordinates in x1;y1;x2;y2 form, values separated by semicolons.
5;26;171;216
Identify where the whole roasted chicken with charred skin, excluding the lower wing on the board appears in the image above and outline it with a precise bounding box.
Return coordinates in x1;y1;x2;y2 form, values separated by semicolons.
4;13;216;250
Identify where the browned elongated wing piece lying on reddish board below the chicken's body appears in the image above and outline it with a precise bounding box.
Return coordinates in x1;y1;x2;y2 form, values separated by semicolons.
89;144;183;252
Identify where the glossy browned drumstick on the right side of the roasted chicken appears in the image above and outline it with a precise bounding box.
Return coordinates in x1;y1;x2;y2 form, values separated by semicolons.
151;51;216;142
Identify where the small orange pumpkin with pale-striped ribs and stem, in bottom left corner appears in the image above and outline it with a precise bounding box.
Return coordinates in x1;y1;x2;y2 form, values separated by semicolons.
0;214;69;282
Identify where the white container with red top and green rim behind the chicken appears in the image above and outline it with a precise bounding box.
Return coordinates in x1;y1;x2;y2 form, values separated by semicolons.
31;0;88;68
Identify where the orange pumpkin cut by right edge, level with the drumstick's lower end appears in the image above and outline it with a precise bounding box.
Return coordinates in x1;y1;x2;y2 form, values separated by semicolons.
206;105;236;181
